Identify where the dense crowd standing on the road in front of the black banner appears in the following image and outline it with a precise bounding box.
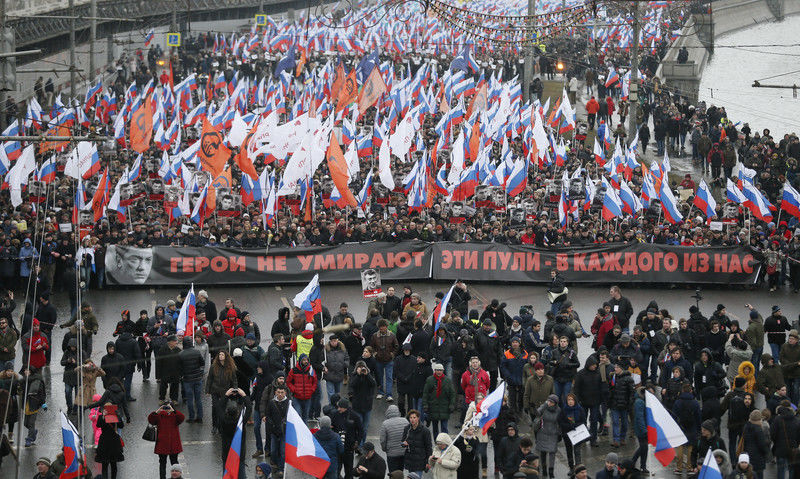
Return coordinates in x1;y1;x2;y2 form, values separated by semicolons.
0;278;800;479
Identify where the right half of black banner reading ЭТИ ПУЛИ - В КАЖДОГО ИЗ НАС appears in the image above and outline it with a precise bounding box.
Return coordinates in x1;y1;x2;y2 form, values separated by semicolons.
431;243;761;284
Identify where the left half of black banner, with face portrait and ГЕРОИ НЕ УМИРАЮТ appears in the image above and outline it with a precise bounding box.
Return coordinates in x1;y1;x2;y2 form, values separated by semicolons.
106;241;431;285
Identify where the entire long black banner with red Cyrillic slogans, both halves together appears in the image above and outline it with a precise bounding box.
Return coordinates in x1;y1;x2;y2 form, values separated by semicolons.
106;241;762;285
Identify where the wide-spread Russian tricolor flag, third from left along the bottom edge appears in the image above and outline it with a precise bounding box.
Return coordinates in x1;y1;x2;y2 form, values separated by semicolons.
284;404;331;479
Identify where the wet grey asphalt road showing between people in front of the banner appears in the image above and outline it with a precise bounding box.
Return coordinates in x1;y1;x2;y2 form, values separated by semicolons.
0;282;800;479
